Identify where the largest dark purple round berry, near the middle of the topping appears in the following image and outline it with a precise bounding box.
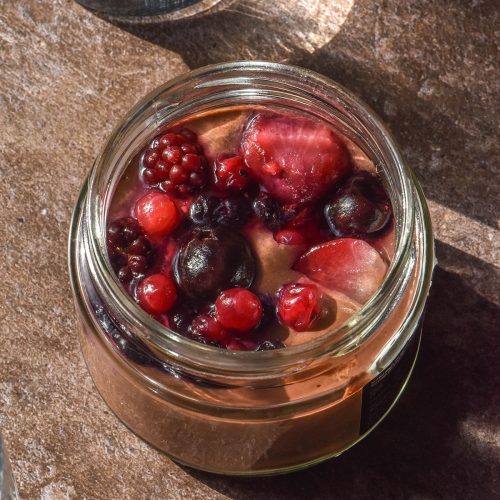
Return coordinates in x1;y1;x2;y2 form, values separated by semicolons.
174;226;256;298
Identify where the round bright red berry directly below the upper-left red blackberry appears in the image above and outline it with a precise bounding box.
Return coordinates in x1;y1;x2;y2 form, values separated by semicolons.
135;191;180;236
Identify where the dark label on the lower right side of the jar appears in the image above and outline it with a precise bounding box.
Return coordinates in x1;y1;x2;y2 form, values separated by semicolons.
359;324;422;435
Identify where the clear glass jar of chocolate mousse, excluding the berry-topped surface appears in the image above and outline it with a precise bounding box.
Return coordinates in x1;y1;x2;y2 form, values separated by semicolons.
69;62;434;475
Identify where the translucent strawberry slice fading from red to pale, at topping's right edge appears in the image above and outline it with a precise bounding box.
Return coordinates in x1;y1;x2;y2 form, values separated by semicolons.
294;238;387;304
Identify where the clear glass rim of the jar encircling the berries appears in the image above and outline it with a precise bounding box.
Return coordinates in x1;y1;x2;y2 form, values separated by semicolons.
82;61;433;375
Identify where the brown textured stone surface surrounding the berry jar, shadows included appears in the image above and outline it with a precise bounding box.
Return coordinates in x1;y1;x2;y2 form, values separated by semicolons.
0;0;500;500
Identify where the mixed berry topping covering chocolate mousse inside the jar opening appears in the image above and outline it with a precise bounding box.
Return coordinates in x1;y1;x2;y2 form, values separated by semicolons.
108;107;394;350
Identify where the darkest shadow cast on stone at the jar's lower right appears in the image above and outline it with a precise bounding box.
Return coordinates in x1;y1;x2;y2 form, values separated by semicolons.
179;242;500;499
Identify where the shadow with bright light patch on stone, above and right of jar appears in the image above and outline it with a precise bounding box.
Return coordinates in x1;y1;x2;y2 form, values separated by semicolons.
100;0;500;227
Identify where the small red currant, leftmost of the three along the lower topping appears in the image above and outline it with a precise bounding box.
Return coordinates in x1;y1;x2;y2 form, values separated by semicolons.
137;274;177;314
